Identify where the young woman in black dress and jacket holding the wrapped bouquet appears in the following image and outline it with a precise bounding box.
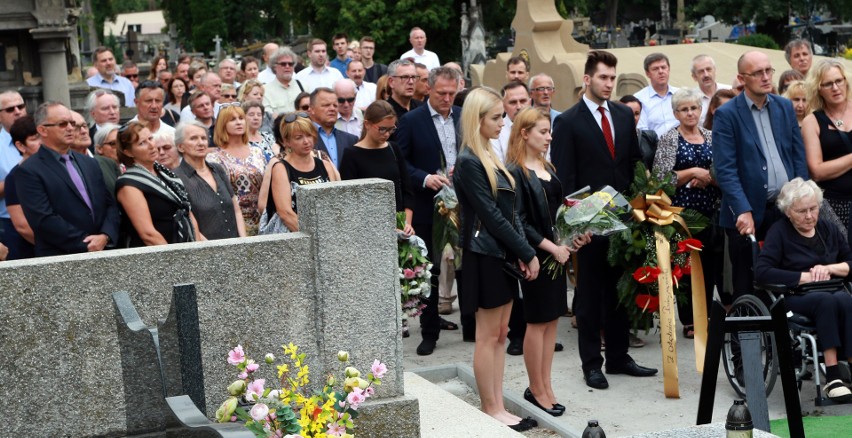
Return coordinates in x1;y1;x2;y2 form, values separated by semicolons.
506;108;591;416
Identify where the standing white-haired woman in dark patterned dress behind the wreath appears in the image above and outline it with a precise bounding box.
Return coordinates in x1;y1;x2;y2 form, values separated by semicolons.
654;89;724;338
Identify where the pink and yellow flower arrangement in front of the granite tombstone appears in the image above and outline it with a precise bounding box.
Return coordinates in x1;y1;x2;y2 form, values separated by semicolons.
216;343;387;438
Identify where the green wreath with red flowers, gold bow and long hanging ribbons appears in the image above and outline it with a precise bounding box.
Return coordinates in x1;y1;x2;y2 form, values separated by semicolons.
608;161;708;398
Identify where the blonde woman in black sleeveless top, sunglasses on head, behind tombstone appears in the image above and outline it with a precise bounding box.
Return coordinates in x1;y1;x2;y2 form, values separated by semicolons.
261;112;340;233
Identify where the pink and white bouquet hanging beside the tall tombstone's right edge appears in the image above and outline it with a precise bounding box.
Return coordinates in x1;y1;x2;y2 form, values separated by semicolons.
396;212;432;320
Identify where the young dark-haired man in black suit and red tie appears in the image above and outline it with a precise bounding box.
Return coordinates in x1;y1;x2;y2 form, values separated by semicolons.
551;51;657;389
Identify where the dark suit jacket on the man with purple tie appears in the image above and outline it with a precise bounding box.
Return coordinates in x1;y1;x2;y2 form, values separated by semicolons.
15;145;118;256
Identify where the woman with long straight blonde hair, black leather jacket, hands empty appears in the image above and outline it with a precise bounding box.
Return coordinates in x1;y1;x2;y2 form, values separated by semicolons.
453;87;540;431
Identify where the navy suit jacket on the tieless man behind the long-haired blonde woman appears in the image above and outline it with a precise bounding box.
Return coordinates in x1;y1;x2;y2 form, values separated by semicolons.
396;104;461;224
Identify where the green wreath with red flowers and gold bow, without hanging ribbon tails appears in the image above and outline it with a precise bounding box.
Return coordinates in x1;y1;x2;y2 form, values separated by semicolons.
608;162;709;331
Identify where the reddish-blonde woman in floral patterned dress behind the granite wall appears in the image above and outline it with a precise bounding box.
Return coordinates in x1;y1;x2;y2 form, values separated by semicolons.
207;105;266;236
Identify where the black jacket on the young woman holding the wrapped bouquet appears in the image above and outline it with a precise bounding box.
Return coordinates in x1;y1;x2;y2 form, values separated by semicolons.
509;165;562;248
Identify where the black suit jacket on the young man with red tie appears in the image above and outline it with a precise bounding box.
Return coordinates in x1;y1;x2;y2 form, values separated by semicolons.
550;99;642;195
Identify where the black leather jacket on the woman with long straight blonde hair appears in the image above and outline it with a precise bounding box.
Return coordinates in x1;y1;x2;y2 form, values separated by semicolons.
453;148;535;263
